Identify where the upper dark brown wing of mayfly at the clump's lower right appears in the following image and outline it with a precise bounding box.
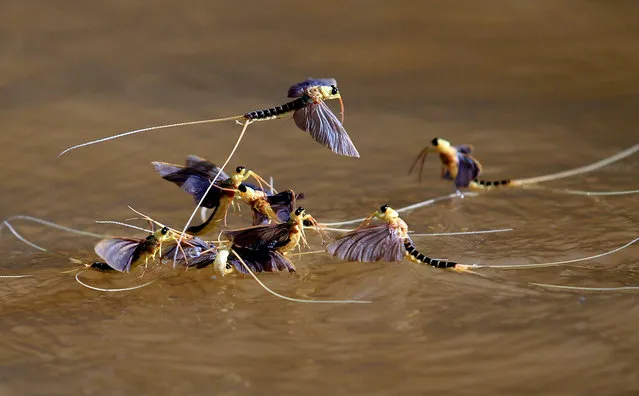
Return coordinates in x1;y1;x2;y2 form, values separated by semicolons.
224;223;289;250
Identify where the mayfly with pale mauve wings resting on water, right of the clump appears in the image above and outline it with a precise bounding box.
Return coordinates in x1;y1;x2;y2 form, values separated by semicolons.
326;205;468;271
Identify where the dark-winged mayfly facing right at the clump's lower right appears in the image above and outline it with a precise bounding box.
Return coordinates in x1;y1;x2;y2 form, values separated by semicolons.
215;207;318;275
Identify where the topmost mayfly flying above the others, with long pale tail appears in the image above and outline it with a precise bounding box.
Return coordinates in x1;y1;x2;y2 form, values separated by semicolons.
58;78;359;157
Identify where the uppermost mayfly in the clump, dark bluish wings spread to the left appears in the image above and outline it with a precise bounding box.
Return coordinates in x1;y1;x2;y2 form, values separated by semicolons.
152;155;266;235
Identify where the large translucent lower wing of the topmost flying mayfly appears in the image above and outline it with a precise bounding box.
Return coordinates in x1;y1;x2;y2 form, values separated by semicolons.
293;102;359;157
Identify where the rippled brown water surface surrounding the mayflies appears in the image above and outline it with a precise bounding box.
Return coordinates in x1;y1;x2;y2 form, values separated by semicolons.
0;0;639;395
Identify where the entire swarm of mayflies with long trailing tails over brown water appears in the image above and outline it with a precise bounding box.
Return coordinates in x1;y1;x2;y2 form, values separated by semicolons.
0;78;639;296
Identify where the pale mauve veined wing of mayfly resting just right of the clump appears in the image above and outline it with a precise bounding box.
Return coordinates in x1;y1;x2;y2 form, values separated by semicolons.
327;224;406;263
